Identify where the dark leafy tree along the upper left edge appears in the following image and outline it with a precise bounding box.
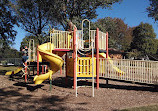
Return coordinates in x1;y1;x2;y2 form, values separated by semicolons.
0;0;18;48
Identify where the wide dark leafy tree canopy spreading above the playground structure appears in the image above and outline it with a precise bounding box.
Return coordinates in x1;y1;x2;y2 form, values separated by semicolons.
12;0;122;42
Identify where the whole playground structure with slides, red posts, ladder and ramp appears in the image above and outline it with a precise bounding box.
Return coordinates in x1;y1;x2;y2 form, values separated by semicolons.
6;19;158;96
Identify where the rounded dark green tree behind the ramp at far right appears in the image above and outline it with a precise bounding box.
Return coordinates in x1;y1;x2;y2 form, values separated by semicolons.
131;22;157;55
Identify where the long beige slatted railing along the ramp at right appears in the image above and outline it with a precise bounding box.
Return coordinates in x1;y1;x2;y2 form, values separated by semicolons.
99;58;158;84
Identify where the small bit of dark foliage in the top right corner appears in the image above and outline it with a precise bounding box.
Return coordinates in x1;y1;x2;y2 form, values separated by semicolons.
147;0;158;21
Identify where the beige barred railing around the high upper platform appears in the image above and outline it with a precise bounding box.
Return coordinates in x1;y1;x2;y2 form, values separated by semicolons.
50;30;106;50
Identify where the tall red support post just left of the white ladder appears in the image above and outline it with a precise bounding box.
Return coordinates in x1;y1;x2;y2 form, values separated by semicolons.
73;28;77;89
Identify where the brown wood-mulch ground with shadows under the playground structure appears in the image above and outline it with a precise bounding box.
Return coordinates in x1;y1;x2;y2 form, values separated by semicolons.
0;72;158;111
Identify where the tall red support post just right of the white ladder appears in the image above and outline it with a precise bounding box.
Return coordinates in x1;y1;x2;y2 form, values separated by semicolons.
96;28;99;89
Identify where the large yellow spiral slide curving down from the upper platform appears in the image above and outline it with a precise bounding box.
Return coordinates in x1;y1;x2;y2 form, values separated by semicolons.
34;42;64;84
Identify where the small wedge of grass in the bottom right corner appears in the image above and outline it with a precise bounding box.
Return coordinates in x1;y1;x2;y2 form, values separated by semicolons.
120;105;158;111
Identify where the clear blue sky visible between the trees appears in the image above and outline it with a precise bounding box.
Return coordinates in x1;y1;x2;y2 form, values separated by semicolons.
13;0;158;50
